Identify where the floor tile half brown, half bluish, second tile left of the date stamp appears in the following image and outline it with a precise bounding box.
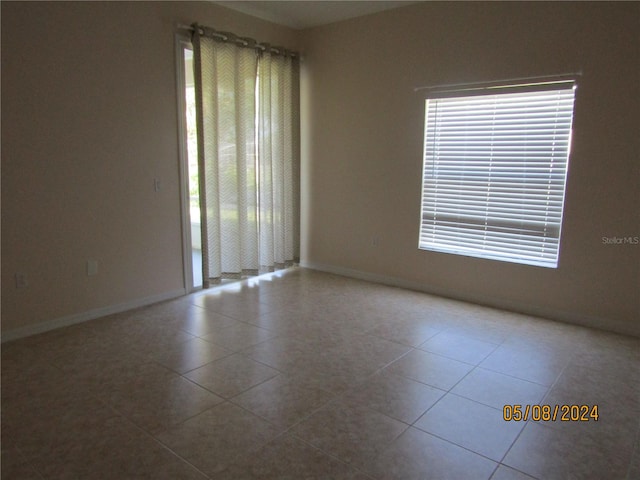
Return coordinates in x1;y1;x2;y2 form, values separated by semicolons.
341;372;445;424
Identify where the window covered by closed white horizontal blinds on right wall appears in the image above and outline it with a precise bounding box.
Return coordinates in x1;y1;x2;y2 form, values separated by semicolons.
419;81;575;268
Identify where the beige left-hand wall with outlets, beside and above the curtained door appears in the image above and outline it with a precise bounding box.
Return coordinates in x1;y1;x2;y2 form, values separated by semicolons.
1;1;297;336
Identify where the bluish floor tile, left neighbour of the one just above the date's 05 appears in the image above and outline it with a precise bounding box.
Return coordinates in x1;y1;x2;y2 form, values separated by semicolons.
387;350;473;390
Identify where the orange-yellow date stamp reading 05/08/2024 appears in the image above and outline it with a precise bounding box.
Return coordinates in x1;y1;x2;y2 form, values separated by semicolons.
502;405;599;422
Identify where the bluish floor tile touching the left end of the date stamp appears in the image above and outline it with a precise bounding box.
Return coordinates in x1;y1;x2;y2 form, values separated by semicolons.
414;394;524;462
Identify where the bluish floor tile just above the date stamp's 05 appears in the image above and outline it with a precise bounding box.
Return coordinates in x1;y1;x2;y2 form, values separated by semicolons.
451;368;547;409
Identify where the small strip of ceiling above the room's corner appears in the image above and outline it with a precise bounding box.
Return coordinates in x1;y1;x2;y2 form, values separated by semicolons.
215;0;416;30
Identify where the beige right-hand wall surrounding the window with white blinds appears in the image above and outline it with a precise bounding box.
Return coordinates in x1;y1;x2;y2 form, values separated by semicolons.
302;2;640;334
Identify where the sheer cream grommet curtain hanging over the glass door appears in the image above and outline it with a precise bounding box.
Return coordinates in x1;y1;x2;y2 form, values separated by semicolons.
193;28;299;288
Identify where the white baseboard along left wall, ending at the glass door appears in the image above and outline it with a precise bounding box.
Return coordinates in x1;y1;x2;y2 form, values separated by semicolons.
2;288;187;343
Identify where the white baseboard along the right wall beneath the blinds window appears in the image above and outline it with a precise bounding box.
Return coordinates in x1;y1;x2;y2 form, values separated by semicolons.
300;261;640;337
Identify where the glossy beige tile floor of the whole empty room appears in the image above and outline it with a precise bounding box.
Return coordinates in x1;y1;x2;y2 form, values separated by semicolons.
2;268;640;480
